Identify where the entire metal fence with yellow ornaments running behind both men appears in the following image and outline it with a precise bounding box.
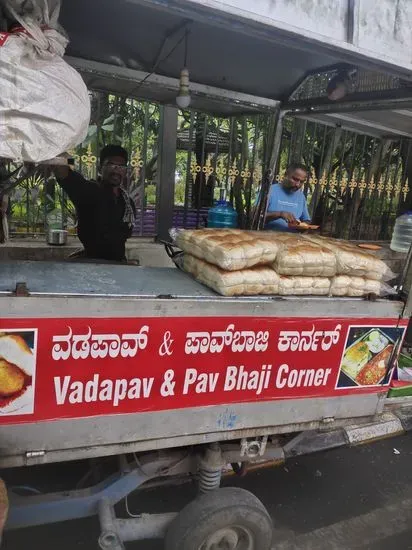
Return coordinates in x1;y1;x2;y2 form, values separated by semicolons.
5;92;412;240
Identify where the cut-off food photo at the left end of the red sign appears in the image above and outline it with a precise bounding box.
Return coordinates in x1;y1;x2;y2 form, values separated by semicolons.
0;329;37;416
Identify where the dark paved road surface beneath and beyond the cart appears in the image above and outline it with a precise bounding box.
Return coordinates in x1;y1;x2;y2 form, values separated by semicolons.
4;435;412;550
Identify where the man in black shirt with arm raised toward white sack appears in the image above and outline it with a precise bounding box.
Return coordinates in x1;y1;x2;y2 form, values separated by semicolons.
55;145;135;262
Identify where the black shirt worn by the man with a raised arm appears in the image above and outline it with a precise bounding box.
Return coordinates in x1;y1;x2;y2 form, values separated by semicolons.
59;171;135;262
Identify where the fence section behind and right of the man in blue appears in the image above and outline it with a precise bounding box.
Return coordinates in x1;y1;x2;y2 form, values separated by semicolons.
277;118;412;240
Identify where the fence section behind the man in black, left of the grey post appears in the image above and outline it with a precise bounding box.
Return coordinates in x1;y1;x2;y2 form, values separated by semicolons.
9;92;161;235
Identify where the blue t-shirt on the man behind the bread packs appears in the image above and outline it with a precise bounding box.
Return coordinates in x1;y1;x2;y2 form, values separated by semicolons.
265;183;310;232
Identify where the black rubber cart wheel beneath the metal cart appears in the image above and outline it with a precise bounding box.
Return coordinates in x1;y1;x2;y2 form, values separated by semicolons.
165;487;273;550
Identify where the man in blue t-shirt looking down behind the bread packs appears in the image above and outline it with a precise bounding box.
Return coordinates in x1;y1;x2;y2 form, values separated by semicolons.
265;164;310;232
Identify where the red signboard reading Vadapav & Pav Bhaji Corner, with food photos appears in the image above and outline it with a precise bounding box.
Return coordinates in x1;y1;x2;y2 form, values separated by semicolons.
0;317;407;424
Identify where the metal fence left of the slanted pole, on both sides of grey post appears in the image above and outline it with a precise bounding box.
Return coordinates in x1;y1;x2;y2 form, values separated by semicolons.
9;92;270;236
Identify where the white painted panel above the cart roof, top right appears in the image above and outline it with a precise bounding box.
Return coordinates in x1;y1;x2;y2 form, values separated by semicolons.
180;0;412;73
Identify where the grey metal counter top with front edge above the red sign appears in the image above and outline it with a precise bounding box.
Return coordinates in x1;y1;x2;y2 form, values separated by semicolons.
0;262;404;319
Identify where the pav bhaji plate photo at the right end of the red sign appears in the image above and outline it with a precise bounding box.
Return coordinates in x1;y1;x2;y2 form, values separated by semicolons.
336;326;405;389
